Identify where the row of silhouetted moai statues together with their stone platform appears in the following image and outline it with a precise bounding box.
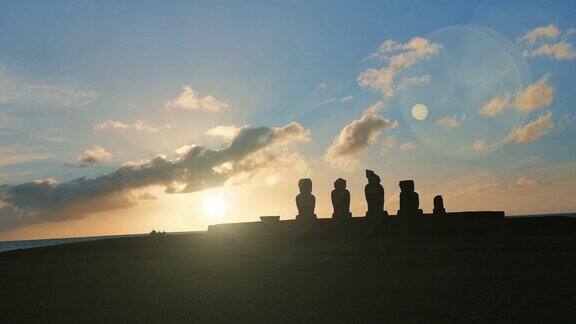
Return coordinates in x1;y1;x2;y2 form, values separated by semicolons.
208;170;505;235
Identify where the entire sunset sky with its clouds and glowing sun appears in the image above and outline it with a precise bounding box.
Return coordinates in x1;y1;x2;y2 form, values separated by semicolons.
0;0;576;240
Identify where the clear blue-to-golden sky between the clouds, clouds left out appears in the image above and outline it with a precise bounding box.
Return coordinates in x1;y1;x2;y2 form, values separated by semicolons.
0;1;576;238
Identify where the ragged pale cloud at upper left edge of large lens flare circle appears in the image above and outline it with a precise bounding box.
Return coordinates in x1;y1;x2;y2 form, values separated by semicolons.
357;37;442;97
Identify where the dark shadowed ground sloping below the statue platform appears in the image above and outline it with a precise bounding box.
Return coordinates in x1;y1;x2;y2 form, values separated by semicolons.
0;218;576;323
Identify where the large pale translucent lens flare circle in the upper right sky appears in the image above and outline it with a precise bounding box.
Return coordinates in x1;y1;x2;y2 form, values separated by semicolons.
397;25;532;159
